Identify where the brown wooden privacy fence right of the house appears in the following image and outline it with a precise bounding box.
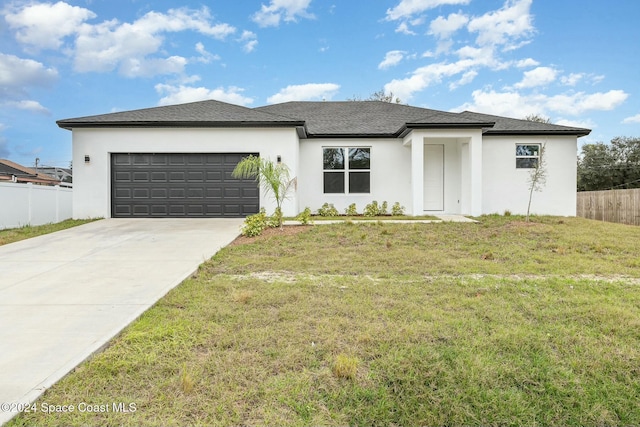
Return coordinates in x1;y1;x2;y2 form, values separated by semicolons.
576;188;640;225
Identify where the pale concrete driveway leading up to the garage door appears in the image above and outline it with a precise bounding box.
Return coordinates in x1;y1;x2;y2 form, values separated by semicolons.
0;219;242;424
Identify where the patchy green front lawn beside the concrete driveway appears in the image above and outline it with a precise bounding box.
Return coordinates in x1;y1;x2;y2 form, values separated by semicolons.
9;217;640;426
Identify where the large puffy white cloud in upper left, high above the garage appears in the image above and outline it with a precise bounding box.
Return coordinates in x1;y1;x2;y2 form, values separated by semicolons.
74;8;236;77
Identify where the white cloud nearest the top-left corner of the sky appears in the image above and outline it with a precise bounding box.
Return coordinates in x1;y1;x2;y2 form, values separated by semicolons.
5;1;96;49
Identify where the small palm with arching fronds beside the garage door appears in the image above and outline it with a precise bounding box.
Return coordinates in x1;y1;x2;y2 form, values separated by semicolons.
231;155;296;227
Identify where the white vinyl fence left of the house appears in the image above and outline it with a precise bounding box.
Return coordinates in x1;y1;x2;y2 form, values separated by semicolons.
0;182;73;230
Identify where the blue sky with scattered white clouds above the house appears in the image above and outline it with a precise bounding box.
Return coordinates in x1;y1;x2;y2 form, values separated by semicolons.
0;0;640;166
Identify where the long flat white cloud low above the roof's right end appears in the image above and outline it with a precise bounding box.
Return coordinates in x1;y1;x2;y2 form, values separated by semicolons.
456;90;629;117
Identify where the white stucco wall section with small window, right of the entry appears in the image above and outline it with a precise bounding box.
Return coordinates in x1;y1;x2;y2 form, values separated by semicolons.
482;136;577;216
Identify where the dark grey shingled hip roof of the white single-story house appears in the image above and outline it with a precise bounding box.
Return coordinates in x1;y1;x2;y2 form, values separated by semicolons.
57;100;591;138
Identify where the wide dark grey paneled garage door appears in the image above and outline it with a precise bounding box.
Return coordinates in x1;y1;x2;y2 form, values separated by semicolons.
111;153;260;218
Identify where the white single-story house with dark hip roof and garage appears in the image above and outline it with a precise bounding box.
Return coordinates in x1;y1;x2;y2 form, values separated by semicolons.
57;100;590;218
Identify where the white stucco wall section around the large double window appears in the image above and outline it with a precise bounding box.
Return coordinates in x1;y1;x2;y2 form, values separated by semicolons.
298;138;411;213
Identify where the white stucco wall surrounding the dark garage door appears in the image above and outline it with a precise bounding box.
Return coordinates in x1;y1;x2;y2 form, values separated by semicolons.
73;128;299;218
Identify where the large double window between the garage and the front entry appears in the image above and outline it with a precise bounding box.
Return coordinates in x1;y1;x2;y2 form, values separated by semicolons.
322;147;371;193
